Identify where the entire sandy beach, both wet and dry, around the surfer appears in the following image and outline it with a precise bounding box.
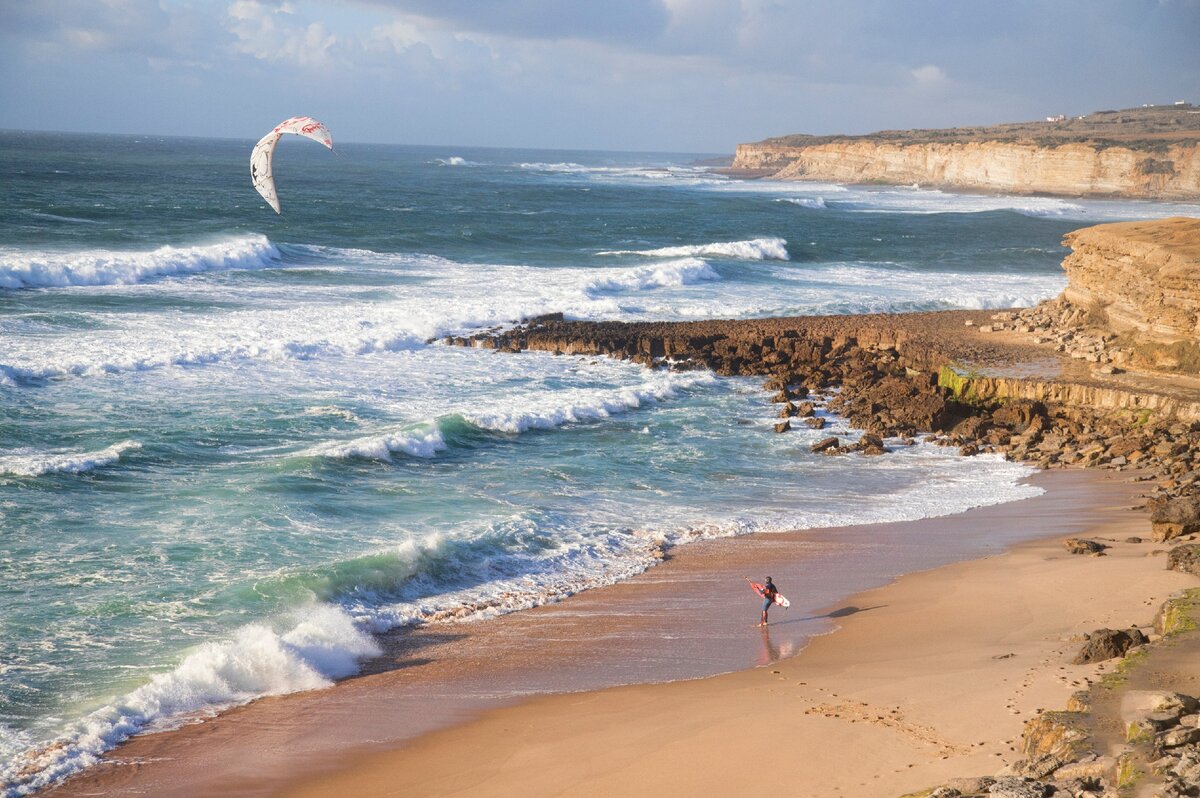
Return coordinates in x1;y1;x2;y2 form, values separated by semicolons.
46;472;1166;796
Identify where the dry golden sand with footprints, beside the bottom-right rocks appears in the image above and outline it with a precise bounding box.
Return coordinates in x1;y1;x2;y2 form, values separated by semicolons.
275;472;1195;798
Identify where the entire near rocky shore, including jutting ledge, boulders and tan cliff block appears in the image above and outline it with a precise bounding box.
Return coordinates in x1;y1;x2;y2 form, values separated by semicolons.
445;218;1200;798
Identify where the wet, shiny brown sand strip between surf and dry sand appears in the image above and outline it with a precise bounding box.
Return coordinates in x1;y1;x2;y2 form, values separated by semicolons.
44;470;1187;796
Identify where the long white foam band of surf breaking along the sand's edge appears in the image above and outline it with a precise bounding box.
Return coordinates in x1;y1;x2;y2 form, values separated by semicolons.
0;427;1040;798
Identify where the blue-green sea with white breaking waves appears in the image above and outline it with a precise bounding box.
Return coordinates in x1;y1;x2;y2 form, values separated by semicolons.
0;132;1200;796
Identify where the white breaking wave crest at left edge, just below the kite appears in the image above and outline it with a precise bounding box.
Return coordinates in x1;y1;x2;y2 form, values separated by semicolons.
0;235;280;288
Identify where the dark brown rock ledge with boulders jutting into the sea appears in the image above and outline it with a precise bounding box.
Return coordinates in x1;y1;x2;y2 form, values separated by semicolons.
446;311;1200;504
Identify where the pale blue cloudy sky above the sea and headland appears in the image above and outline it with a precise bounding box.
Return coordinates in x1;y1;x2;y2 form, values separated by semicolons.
0;0;1200;154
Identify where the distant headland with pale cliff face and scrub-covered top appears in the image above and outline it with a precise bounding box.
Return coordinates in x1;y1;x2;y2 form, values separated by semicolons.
732;106;1200;200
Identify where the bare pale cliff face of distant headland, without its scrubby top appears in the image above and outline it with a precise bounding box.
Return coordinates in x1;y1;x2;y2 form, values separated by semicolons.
733;137;1200;199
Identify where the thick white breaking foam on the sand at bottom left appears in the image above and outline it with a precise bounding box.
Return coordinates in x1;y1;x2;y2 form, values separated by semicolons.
0;605;379;798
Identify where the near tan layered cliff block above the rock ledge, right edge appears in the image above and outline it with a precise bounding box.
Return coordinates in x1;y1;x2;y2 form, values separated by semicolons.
1062;217;1200;343
